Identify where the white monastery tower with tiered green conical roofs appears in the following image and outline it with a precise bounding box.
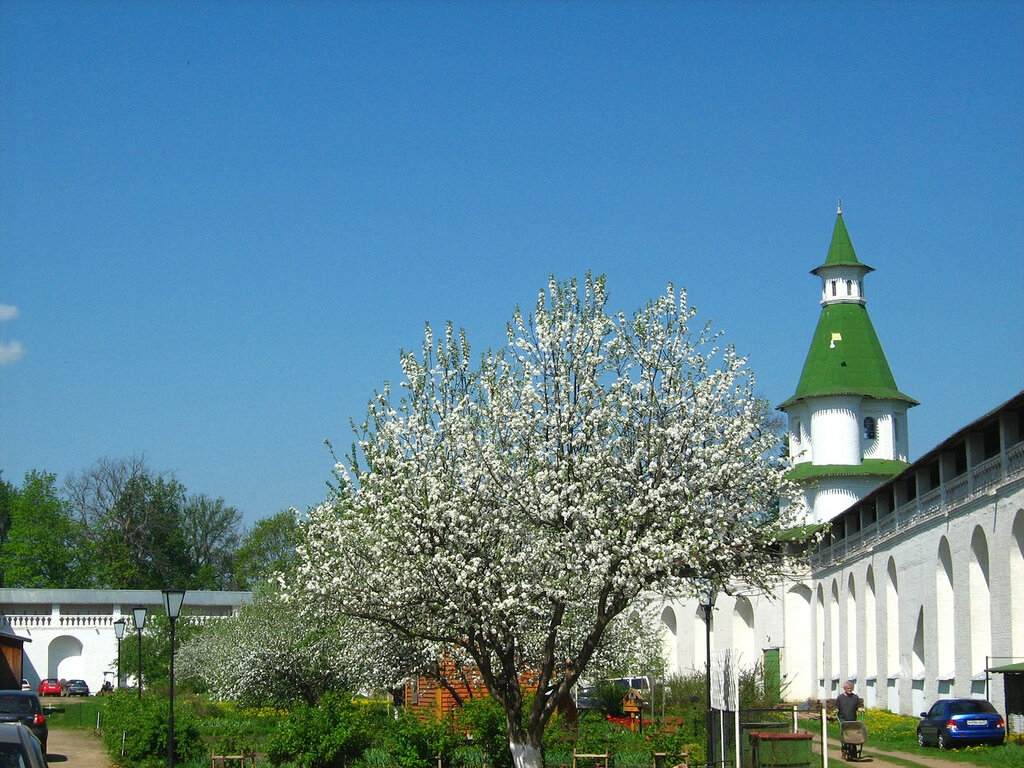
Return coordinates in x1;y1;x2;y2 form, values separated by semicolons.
778;205;918;523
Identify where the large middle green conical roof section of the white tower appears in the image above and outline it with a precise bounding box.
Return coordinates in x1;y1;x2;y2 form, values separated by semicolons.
778;304;918;410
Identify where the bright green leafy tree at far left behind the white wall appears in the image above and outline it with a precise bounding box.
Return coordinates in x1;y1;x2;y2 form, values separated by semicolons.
0;470;82;589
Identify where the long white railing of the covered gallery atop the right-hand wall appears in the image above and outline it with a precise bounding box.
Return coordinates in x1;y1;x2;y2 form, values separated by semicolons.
809;441;1024;568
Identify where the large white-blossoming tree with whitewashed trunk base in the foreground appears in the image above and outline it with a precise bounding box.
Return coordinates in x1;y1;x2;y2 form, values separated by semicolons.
290;275;790;768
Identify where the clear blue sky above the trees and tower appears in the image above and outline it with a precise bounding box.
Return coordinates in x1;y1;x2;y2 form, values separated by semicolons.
0;0;1024;522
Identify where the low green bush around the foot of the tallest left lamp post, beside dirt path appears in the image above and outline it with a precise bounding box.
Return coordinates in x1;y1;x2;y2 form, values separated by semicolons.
100;690;206;768
